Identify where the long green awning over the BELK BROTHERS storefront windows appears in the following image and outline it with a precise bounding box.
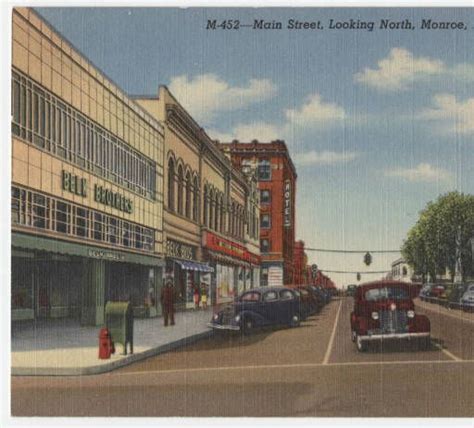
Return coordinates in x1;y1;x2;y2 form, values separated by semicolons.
12;232;165;266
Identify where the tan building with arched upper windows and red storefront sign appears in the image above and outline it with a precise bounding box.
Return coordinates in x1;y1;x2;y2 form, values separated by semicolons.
135;86;260;306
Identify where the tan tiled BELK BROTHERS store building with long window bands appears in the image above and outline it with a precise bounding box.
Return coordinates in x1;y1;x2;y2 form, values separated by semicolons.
11;8;165;324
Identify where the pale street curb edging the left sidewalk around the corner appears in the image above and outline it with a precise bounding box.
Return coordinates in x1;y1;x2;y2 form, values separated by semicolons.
11;330;213;376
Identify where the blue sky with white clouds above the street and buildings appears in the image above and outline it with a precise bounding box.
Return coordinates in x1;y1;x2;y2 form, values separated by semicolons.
38;8;474;285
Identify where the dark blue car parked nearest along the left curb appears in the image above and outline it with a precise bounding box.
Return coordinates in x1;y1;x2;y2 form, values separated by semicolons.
208;287;304;334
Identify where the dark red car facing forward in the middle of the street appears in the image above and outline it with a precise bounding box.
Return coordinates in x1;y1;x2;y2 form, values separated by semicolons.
350;281;431;351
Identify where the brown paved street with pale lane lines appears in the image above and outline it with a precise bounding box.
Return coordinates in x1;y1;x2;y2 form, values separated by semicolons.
11;298;474;417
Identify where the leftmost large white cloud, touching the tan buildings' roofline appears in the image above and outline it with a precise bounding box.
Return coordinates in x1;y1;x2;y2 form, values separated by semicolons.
169;74;276;122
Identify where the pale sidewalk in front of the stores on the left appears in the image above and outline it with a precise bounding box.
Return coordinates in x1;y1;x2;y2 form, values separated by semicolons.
11;309;212;376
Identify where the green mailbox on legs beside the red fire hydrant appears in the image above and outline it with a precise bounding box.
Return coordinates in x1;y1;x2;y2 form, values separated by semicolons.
105;302;133;355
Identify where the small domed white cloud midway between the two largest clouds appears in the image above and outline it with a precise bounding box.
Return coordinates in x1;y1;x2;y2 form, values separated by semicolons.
285;94;345;127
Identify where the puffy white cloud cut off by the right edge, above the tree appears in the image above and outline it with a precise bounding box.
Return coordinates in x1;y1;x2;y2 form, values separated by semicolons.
418;94;474;134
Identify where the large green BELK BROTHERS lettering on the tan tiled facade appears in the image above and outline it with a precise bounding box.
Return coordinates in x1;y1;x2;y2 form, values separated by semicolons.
62;170;133;214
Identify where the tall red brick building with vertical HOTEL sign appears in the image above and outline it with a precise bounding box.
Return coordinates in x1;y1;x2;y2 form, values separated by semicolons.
220;140;297;285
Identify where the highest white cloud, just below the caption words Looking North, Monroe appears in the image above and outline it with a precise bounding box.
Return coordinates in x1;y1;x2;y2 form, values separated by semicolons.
354;48;446;91
